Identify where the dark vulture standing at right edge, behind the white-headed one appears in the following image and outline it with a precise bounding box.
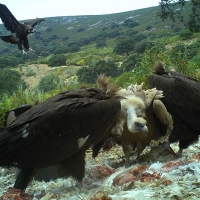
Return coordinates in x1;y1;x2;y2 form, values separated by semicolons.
148;62;200;156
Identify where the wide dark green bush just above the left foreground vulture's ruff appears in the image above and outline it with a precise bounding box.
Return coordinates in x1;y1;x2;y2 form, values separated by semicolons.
76;60;122;83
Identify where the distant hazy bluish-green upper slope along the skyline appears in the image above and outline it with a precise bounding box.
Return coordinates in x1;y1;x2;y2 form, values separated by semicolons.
0;7;188;58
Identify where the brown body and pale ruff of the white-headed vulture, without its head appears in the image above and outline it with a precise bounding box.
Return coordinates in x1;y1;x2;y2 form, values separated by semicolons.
117;85;169;167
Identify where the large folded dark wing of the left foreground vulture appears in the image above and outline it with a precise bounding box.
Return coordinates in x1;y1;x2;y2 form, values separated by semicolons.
0;91;121;168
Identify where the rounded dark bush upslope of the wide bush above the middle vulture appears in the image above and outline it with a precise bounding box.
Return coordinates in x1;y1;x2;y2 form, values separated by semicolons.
113;38;134;56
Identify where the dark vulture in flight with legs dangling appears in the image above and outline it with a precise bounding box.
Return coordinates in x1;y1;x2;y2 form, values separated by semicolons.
0;4;45;54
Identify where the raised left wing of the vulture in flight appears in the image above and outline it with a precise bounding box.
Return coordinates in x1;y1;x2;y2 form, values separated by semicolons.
0;4;21;33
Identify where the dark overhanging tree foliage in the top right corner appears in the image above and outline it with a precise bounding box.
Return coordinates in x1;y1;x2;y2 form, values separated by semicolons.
156;0;200;32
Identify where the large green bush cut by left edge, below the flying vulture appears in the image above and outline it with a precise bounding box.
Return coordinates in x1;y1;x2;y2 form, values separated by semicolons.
0;68;26;96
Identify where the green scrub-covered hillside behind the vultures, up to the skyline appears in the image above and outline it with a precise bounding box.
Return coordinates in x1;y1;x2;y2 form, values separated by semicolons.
0;1;200;126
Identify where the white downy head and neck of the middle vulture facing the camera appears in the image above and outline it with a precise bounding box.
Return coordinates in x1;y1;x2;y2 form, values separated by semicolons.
121;95;148;134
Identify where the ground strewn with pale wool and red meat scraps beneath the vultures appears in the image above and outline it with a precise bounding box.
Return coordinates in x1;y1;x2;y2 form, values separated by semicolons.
0;138;200;200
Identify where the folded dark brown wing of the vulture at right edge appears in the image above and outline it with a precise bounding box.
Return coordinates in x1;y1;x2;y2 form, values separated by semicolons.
148;73;200;130
